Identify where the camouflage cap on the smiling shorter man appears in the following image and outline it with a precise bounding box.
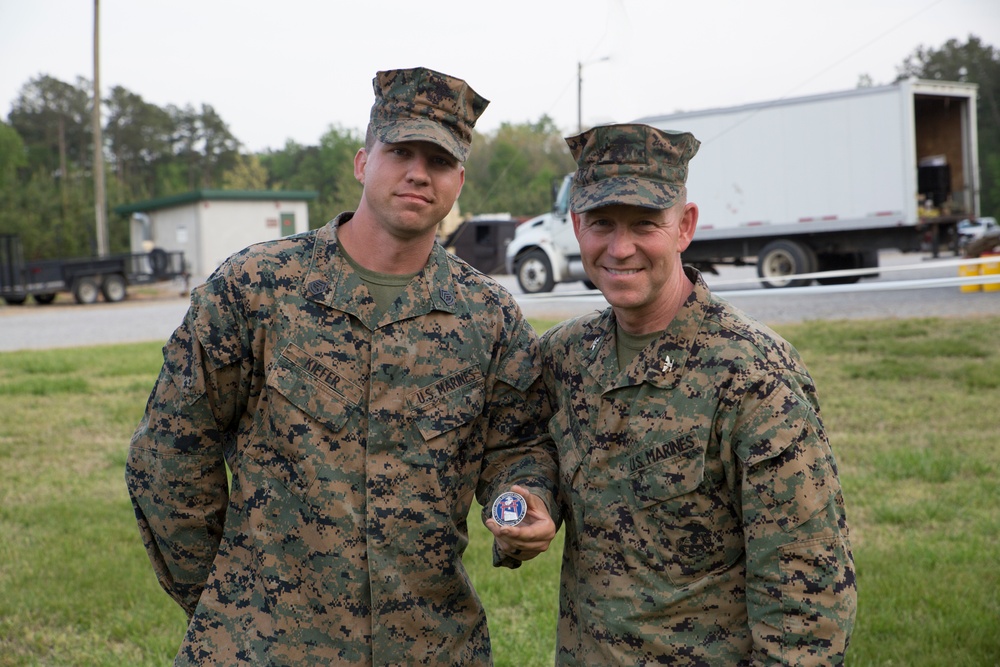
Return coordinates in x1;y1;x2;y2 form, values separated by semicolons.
566;124;701;213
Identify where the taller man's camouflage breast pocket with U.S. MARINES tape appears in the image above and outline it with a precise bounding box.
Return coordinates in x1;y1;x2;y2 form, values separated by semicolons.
403;366;486;474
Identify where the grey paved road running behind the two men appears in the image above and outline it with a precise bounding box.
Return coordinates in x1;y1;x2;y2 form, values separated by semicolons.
0;253;1000;351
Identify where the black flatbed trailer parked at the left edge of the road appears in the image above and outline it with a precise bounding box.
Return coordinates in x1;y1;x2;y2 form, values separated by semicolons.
0;234;188;305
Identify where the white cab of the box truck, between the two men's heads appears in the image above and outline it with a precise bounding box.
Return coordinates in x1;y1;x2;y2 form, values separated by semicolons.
505;174;594;294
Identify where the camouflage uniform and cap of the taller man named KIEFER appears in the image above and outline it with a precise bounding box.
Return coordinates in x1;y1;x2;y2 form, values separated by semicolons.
126;68;556;666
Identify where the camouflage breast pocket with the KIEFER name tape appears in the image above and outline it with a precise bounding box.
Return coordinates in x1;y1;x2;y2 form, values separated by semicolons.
246;346;360;497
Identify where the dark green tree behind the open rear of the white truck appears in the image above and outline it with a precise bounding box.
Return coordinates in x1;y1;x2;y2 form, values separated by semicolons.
897;35;1000;215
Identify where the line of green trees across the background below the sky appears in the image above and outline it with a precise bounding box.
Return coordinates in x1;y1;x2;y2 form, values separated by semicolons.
0;35;1000;259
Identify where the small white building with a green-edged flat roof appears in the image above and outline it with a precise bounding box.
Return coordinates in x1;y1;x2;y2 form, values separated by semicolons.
114;190;317;284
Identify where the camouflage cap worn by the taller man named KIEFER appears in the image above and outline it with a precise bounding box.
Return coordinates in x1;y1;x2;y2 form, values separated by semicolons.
371;67;490;162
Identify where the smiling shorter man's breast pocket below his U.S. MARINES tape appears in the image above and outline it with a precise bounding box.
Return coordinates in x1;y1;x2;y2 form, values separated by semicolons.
627;434;743;585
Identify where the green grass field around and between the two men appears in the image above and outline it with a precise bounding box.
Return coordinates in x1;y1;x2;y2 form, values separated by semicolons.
0;317;1000;667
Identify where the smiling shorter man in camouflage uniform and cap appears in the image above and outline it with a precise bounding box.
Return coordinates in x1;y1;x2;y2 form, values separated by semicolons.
542;125;856;666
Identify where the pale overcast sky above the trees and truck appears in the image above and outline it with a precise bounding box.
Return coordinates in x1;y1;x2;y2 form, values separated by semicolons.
0;0;1000;151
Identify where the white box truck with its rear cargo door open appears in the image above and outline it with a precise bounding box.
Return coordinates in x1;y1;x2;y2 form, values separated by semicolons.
505;79;979;293
